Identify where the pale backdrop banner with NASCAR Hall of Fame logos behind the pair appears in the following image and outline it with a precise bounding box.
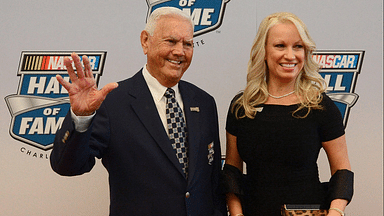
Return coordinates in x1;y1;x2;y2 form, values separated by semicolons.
0;0;383;216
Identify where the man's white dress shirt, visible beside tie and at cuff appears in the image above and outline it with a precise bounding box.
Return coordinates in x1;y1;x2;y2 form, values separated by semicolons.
71;65;186;134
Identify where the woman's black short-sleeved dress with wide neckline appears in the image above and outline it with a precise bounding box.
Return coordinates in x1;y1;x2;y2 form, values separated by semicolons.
226;94;345;216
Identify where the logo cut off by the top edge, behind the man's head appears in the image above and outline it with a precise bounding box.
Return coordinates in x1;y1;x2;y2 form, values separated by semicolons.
147;0;230;36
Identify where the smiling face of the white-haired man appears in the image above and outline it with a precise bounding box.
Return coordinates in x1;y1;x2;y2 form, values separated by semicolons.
140;15;193;87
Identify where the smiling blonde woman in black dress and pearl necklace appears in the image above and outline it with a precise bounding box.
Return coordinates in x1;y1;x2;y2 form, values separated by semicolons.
223;13;353;216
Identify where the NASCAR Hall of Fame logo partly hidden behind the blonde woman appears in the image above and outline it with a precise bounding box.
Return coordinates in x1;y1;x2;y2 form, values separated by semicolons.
313;51;364;126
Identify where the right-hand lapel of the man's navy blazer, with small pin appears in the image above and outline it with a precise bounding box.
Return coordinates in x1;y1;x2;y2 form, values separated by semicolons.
179;81;201;182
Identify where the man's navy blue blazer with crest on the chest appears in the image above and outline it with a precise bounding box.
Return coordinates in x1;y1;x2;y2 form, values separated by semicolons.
50;71;226;216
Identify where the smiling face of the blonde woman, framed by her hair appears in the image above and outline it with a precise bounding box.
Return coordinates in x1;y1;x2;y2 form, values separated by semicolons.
265;22;305;83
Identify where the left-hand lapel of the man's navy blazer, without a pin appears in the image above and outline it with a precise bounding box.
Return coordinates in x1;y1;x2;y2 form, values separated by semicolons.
128;71;184;175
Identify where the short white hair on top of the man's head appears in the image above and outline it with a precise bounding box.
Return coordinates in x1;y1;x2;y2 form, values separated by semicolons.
144;7;194;36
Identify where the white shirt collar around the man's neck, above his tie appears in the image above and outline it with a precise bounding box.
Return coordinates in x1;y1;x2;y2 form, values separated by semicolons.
143;64;179;102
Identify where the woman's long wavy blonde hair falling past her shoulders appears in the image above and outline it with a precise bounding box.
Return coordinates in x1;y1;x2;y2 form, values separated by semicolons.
232;12;325;119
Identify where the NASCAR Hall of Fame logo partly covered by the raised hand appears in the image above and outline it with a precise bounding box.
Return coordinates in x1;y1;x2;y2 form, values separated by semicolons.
5;51;107;150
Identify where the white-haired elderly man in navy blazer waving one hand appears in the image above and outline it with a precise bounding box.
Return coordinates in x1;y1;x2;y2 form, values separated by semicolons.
50;7;226;216
